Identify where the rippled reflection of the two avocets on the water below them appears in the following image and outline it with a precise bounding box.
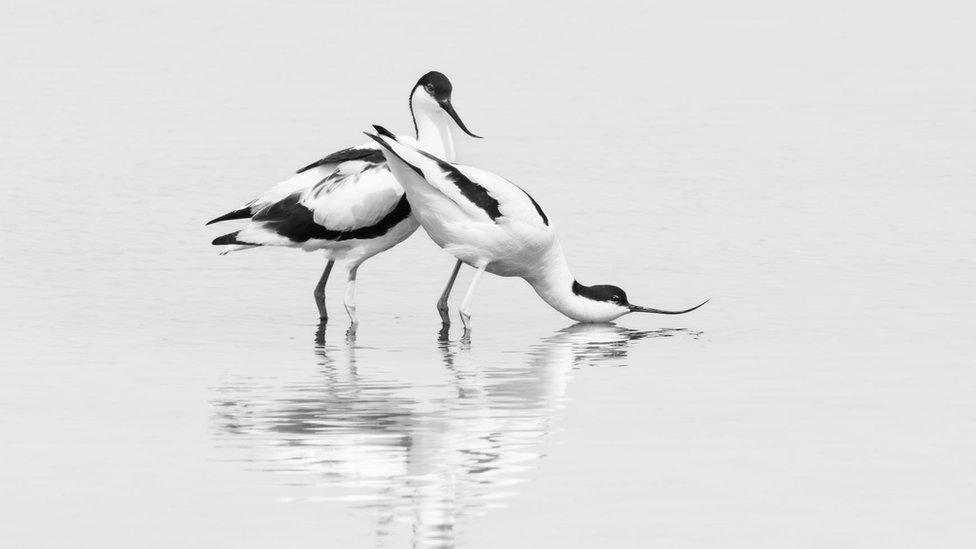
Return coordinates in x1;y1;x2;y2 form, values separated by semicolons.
215;324;698;546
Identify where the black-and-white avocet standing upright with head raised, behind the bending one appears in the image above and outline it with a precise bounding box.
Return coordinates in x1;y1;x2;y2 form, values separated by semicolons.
207;71;479;324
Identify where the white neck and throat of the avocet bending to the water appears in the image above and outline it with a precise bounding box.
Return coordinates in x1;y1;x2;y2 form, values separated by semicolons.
525;241;627;322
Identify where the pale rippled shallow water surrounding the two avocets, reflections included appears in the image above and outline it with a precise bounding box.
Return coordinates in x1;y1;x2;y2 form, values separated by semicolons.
0;2;976;547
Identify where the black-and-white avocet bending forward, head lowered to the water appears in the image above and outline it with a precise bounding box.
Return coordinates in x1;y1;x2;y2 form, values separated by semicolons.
366;126;707;332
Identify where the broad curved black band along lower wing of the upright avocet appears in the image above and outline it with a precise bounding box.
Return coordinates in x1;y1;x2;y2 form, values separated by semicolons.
231;193;418;244
